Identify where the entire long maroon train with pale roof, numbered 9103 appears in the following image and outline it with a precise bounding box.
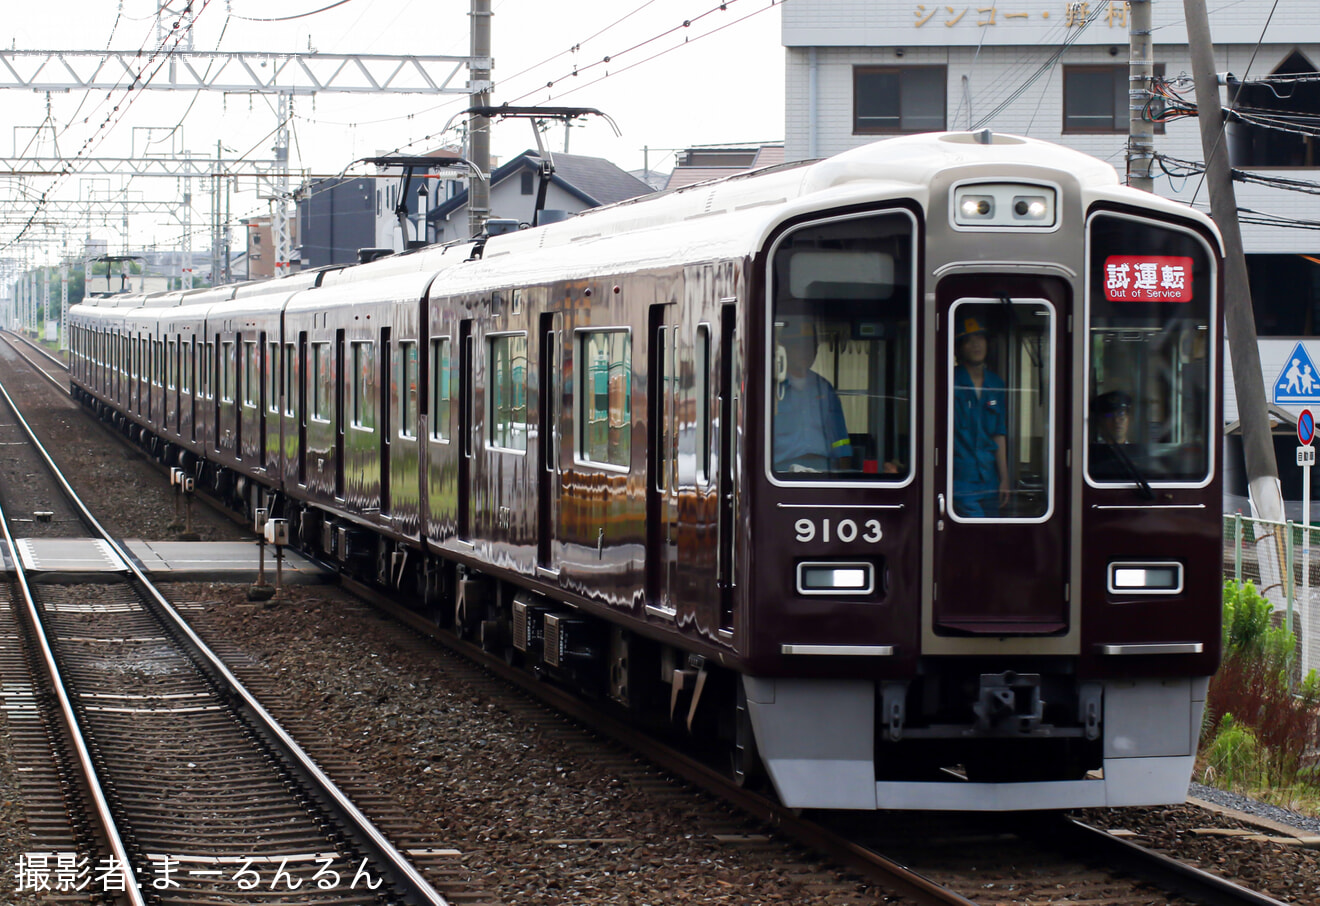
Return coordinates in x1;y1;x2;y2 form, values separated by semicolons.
71;133;1222;810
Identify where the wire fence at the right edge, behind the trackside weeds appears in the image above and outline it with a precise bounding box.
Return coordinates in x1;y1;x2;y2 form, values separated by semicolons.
1224;514;1320;676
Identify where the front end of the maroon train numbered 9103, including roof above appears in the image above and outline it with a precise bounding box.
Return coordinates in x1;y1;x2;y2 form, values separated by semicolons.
738;133;1221;810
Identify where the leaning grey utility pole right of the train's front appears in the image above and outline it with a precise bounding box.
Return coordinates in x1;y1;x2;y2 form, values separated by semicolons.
1183;0;1283;522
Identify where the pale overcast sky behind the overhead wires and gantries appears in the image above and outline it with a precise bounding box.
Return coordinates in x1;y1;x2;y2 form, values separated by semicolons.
0;0;784;266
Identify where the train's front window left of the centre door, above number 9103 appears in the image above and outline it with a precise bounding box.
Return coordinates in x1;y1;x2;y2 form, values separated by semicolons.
767;211;913;482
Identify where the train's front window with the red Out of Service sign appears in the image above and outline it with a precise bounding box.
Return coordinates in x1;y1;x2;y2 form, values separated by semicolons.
1086;214;1214;486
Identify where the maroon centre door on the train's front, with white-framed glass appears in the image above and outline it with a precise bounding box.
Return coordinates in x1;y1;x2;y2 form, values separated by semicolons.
927;282;1071;638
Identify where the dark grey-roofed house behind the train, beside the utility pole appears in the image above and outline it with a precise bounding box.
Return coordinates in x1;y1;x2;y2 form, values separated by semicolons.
426;151;652;242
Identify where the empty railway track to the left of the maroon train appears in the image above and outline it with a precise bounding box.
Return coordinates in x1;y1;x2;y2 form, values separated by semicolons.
0;356;477;905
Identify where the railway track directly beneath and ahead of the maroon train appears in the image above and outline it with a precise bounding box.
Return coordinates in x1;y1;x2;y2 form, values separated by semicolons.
0;328;1298;906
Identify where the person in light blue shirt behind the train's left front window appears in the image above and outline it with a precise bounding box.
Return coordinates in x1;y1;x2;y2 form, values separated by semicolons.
774;318;853;473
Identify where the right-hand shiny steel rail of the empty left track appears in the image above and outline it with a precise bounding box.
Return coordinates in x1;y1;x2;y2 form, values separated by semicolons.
0;368;447;906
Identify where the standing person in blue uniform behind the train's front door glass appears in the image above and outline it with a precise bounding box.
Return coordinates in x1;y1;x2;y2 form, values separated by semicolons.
953;318;1008;519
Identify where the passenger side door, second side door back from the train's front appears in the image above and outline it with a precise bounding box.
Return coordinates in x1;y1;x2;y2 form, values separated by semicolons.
647;302;678;617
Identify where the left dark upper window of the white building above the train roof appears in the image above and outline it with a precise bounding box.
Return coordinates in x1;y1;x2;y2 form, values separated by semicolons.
853;66;948;135
